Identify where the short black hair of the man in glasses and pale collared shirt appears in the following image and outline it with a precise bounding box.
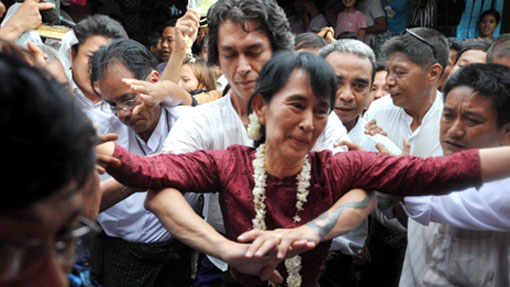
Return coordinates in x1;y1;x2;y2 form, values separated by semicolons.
90;39;157;83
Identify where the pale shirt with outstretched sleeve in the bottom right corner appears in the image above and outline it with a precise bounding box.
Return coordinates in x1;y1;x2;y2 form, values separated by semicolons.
400;178;510;287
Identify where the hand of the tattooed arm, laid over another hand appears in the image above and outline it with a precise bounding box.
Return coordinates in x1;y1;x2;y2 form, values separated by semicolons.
237;225;320;259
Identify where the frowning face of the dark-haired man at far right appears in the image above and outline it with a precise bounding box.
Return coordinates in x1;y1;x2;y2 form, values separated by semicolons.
441;86;503;155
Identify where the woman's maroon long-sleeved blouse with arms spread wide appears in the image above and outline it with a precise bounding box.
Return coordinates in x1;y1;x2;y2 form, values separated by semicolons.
108;145;481;286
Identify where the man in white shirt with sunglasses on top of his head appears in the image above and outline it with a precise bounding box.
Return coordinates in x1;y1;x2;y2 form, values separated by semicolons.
365;28;448;286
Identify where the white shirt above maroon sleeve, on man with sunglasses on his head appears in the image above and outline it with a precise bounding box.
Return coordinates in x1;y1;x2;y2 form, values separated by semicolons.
365;92;443;157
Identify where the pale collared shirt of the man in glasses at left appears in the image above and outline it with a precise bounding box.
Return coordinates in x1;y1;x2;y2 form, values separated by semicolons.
88;106;198;243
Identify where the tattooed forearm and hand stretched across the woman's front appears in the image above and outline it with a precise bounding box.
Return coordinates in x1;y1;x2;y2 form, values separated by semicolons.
238;189;376;259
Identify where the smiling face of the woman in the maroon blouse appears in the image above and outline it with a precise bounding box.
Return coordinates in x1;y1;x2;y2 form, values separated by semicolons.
254;69;330;162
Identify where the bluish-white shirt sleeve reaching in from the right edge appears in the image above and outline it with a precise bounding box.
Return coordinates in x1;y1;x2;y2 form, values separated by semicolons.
404;178;510;232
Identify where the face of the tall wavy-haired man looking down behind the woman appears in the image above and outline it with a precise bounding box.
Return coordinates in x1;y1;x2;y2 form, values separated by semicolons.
218;20;272;100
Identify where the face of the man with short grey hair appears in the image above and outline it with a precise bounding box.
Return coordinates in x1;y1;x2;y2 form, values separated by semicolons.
326;52;373;131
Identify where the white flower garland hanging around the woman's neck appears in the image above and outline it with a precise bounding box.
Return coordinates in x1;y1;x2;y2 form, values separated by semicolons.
248;143;312;287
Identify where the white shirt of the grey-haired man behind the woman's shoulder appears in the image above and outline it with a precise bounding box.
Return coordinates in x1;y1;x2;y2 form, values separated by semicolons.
331;117;401;255
